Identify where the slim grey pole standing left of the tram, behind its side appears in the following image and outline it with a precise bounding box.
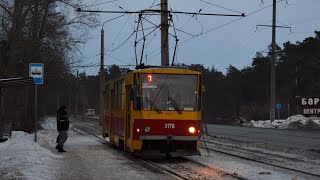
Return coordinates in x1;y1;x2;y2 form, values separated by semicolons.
100;26;104;123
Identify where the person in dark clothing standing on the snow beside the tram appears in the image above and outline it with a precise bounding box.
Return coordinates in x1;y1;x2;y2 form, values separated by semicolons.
56;105;69;152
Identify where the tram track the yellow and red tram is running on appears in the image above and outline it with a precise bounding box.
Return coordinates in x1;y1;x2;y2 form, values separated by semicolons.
71;121;245;180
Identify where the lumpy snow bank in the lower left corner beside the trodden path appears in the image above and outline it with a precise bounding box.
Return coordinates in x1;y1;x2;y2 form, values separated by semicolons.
0;131;61;179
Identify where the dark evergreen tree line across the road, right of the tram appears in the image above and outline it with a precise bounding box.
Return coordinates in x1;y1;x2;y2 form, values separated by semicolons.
199;31;320;122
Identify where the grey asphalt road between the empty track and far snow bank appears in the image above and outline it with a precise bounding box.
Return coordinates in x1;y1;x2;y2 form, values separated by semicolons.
207;124;320;150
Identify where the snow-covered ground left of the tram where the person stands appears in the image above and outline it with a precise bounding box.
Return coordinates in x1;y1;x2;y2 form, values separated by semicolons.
0;118;173;180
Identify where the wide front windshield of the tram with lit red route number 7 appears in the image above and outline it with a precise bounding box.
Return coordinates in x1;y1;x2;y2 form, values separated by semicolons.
141;74;198;113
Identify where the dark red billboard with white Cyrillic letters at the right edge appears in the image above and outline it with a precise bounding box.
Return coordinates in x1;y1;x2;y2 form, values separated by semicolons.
296;97;320;115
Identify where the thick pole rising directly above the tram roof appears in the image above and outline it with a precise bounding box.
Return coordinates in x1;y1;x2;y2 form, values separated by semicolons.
161;0;169;66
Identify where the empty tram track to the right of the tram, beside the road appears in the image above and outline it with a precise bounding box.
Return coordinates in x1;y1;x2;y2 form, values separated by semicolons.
200;140;320;178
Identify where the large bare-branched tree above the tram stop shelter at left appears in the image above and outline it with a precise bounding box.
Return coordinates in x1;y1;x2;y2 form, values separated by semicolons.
0;0;98;130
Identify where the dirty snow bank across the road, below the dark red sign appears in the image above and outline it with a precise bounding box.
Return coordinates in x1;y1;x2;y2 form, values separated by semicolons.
243;114;320;129
